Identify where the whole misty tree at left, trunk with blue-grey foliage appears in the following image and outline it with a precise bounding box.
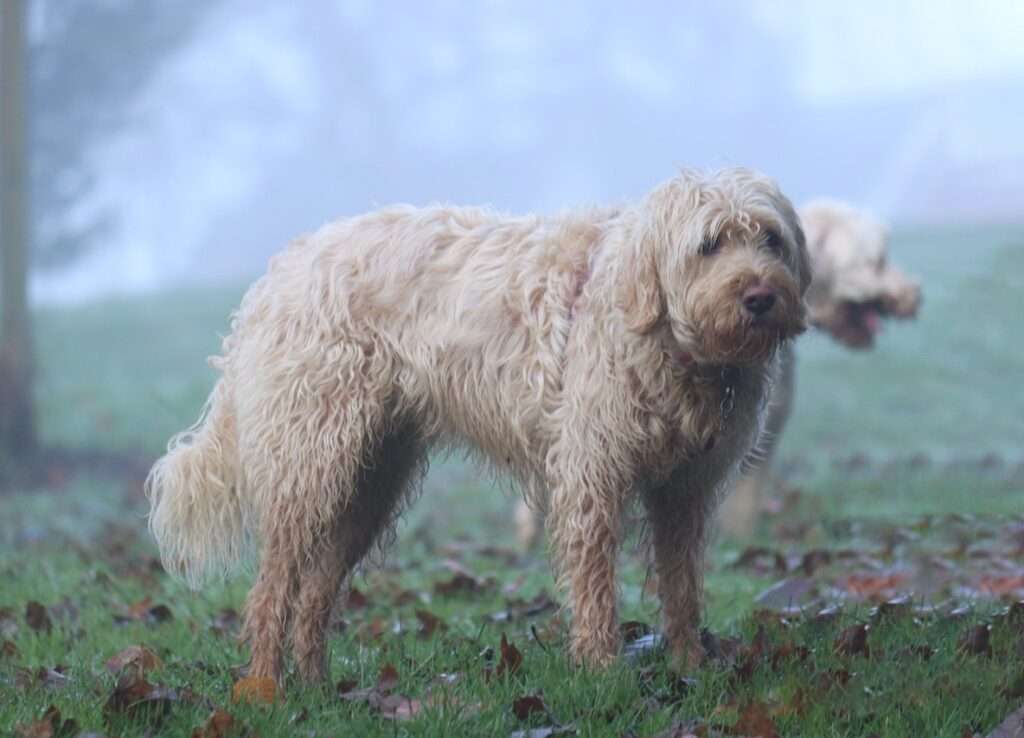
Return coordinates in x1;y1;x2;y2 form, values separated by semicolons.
0;0;216;463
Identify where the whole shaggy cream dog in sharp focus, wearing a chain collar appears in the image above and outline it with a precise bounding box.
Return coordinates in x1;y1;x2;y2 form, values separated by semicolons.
147;169;810;682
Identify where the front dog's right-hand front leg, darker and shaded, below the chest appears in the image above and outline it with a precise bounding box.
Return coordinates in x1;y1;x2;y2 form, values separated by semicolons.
644;483;708;669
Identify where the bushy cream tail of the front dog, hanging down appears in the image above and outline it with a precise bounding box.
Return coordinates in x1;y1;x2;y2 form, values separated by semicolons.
145;380;250;589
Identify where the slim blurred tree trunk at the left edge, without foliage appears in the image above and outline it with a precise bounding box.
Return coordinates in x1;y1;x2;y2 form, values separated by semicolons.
0;0;36;462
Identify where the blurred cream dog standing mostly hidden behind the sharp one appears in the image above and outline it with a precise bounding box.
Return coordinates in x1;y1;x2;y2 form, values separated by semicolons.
716;200;921;537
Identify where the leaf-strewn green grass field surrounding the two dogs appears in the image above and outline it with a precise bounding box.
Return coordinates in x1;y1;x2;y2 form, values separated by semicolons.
0;228;1024;738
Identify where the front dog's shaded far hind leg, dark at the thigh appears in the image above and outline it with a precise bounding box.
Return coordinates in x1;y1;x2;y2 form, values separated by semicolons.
292;428;424;682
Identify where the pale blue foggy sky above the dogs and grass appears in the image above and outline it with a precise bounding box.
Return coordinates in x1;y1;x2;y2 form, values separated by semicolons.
28;0;1024;301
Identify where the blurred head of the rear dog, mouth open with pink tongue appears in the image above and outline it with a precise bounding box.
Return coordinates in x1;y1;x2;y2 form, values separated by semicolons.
800;200;921;349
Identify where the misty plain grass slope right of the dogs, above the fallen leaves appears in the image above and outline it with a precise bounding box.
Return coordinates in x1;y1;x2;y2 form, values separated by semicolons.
781;228;1024;461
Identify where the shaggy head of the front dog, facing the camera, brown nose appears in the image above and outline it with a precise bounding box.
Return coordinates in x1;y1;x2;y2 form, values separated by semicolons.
622;169;811;364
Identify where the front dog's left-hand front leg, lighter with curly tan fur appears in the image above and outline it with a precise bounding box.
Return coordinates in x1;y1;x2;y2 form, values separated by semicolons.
548;466;622;666
